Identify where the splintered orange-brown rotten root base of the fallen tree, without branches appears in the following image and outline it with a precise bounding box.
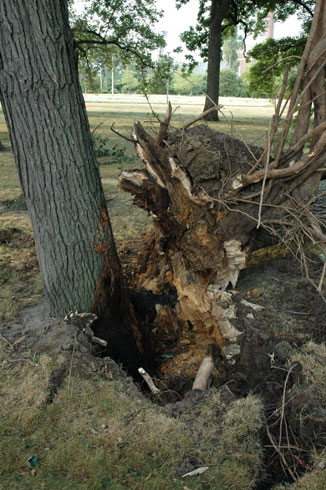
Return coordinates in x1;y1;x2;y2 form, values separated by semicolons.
120;123;262;366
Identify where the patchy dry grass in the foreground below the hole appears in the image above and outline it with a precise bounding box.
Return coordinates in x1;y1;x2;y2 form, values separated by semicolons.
0;350;262;490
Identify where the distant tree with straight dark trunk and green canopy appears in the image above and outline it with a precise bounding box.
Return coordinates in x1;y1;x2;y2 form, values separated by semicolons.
176;0;315;121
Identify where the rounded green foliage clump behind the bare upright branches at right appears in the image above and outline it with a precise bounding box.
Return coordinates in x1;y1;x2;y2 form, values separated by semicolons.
246;35;307;97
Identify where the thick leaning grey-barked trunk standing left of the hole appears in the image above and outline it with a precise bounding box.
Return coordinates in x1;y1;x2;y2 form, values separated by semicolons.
0;0;141;368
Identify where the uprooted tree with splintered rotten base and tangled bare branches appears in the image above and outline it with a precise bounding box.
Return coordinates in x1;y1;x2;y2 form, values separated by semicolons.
120;0;326;376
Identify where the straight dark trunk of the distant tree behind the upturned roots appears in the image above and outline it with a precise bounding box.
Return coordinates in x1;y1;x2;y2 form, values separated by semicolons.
204;0;231;121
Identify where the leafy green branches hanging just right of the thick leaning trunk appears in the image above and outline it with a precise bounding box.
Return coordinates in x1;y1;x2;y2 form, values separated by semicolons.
70;0;165;77
